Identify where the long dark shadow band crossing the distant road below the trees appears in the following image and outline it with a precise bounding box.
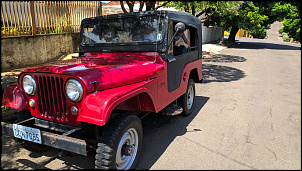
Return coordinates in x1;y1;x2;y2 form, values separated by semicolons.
231;39;301;50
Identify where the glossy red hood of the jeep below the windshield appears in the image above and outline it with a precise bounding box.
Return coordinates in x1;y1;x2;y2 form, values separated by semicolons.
23;52;165;92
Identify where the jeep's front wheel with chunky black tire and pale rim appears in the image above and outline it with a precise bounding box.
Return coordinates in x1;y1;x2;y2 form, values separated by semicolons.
95;114;143;170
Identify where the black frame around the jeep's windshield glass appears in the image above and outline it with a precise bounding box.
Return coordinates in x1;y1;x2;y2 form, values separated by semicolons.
80;14;167;47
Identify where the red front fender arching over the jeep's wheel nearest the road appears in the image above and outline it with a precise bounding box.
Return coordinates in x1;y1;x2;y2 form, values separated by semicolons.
77;79;155;126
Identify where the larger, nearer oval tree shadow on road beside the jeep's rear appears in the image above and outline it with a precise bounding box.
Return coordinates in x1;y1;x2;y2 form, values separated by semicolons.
202;64;246;83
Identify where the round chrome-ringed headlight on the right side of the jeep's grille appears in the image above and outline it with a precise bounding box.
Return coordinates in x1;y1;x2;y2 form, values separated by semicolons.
65;78;83;102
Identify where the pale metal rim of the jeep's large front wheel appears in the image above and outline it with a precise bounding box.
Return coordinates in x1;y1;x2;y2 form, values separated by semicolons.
116;128;138;170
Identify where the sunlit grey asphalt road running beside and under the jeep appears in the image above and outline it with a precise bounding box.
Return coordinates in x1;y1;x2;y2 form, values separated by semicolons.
1;23;301;170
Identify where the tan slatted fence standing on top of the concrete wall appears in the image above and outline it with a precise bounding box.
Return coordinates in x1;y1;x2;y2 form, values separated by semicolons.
1;1;99;37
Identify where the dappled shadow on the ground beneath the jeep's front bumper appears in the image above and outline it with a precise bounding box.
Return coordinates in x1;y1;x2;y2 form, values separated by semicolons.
1;135;94;170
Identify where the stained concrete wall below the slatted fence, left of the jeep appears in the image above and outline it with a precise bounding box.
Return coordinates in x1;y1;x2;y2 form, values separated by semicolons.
1;33;80;69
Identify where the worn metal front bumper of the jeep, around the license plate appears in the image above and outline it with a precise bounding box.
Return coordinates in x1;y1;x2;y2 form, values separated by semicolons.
1;117;87;156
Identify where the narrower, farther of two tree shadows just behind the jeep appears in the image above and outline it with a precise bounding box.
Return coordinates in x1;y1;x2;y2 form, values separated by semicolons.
202;54;246;63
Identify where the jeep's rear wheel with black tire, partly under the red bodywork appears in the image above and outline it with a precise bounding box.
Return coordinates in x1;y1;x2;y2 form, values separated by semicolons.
179;78;195;116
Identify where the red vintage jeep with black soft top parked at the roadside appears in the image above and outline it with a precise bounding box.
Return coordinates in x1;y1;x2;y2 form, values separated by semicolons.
1;11;202;169
